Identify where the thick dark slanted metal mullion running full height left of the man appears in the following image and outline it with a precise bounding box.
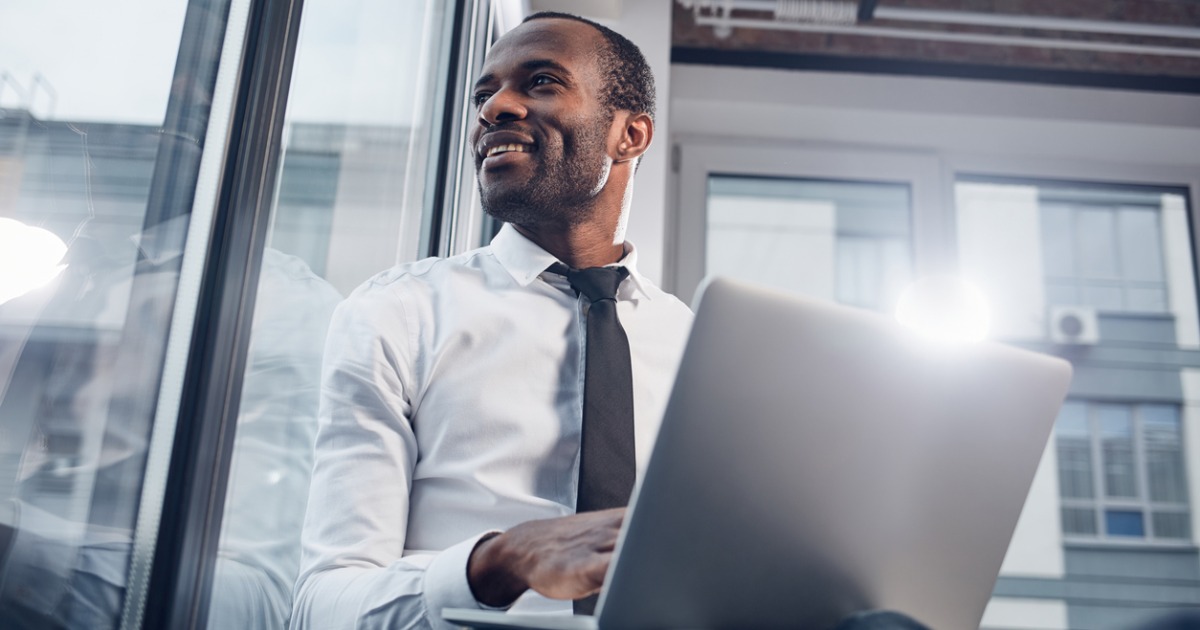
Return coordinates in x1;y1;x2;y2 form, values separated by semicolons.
133;0;302;629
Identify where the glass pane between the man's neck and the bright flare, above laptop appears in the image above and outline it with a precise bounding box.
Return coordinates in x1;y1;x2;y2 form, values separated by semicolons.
706;175;912;310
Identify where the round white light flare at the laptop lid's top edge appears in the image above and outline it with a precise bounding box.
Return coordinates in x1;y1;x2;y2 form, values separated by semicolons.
895;276;991;346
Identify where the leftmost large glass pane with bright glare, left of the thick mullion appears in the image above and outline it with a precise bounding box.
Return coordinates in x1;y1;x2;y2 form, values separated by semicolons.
0;0;228;629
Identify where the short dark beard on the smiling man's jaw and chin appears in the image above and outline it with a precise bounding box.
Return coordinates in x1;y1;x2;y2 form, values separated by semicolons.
475;111;611;227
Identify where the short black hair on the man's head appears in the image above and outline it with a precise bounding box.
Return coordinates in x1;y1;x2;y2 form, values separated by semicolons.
521;11;655;120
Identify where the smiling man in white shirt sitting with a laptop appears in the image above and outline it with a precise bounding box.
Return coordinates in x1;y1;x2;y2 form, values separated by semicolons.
293;13;691;628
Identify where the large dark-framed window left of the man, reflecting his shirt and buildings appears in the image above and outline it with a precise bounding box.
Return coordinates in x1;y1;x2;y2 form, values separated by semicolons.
0;0;472;629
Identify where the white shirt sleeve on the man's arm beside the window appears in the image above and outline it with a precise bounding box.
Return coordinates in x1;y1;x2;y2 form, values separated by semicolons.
292;287;486;630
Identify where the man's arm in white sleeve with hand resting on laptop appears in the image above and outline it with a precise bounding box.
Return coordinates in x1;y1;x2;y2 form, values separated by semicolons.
293;285;623;628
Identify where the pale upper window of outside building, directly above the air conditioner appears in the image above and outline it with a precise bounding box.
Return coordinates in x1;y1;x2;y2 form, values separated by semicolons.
1040;199;1168;313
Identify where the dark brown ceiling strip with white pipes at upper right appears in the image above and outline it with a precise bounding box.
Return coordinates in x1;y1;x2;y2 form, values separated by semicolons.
672;0;1200;94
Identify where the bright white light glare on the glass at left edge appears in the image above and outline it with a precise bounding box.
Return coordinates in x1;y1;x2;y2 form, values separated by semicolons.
0;217;67;304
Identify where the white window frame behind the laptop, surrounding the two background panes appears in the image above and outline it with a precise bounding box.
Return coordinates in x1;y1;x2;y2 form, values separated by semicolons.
664;134;1200;547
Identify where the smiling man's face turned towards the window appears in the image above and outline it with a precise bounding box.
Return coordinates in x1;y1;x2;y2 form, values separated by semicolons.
470;18;613;226
